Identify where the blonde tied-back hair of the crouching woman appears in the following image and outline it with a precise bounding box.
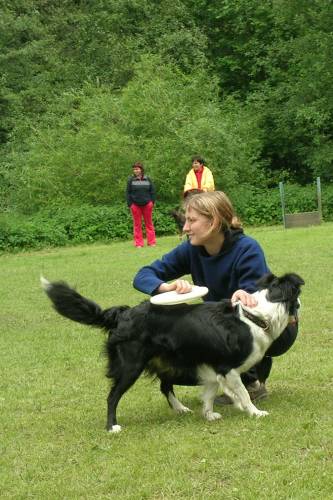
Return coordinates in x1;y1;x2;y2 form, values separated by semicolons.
184;191;242;232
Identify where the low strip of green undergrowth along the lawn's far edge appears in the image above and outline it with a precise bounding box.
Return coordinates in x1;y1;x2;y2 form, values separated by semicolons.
0;185;333;251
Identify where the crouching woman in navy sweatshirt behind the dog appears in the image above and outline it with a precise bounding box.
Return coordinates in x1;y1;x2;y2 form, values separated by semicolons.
133;191;297;403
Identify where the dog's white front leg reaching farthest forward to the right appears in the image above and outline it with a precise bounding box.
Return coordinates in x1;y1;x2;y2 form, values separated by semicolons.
220;370;268;417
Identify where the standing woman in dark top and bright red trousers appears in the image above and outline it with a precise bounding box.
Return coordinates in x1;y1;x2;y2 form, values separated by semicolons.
126;162;156;248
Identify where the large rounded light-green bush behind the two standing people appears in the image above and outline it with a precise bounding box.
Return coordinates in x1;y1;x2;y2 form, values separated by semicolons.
8;58;264;212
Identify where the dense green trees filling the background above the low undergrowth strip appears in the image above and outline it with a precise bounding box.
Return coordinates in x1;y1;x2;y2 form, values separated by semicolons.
0;0;333;214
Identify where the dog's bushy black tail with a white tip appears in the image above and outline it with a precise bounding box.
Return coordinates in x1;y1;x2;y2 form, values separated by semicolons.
40;277;129;330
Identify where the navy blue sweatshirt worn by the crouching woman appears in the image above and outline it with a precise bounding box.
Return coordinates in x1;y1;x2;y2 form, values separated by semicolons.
133;230;269;301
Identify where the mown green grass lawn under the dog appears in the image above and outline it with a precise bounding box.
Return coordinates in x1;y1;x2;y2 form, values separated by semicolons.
0;228;333;500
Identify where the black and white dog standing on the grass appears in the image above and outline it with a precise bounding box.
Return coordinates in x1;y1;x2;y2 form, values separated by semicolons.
42;273;304;432
